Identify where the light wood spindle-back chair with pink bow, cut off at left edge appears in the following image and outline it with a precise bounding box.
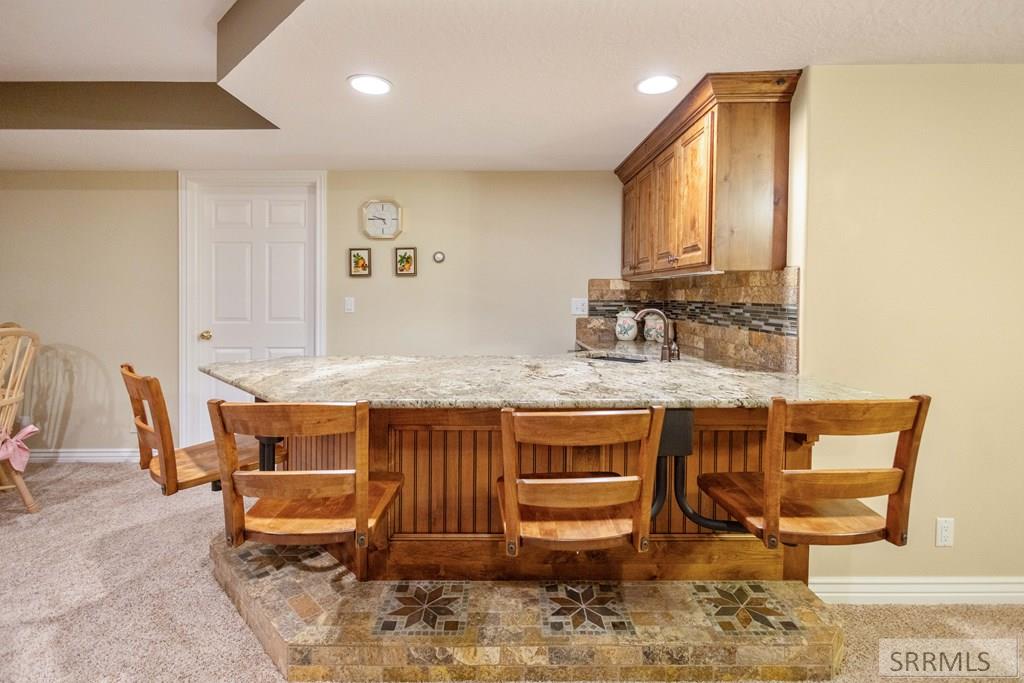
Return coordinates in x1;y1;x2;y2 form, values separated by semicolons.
0;323;39;512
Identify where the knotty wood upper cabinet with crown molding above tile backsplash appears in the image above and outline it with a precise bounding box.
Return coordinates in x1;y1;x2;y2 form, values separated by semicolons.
615;71;800;280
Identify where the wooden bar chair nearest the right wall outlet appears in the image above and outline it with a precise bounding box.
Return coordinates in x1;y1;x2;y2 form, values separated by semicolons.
697;396;931;548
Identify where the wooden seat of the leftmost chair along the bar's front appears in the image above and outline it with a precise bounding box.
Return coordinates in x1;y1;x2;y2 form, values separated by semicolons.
245;472;402;545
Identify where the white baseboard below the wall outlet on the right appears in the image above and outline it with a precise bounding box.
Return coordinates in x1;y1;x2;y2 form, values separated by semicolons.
809;577;1024;605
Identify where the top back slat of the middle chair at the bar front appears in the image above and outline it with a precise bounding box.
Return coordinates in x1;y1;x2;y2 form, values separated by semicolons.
513;411;650;445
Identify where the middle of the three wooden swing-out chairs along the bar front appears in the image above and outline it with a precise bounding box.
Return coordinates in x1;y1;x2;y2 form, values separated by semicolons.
498;408;665;557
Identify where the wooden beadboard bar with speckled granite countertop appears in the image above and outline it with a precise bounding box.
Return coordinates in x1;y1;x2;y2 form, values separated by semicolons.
202;354;874;582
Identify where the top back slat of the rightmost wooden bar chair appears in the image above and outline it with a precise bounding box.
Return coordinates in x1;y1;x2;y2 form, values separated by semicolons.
785;399;919;436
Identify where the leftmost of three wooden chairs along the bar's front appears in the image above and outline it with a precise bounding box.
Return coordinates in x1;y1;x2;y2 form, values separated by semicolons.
209;400;402;581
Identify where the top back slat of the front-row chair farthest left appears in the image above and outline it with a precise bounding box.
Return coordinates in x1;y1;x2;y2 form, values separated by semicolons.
220;402;355;436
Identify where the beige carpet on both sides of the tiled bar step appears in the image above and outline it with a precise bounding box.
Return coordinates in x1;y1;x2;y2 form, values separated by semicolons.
0;464;1024;683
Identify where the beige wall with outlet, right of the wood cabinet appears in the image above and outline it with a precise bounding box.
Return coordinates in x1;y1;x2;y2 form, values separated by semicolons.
791;65;1024;577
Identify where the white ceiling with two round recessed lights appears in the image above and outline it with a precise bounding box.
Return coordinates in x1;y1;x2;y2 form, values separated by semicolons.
0;0;1024;170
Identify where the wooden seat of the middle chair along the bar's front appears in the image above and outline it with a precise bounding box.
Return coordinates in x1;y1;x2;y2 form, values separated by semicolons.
498;472;634;550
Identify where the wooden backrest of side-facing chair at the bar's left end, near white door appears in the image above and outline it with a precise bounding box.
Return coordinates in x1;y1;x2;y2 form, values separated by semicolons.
121;362;178;489
